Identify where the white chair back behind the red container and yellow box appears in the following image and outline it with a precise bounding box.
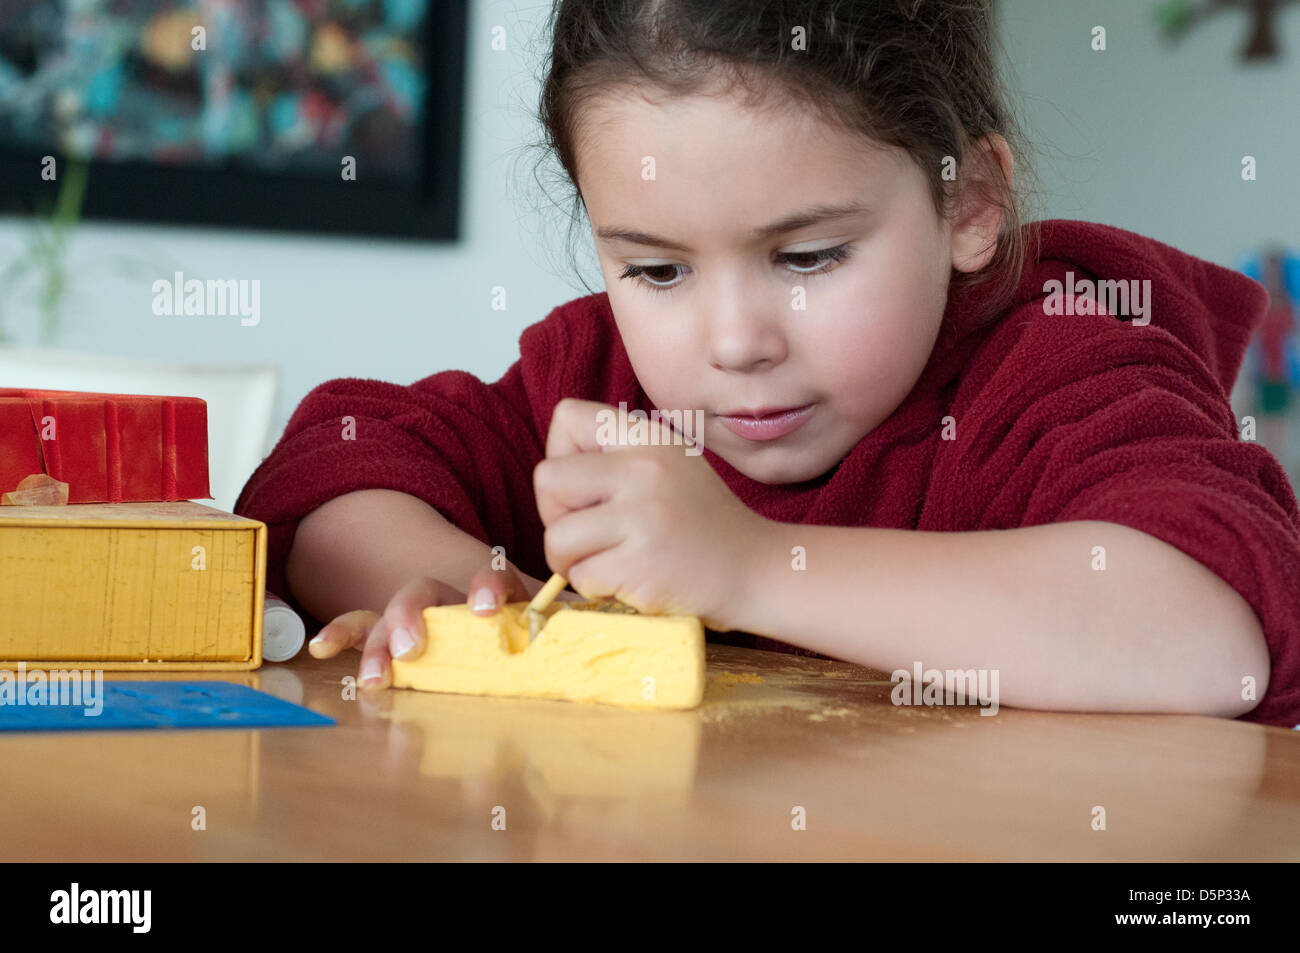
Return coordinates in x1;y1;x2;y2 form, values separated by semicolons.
0;347;278;511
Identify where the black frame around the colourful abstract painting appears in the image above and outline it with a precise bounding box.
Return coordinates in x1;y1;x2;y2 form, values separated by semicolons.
0;0;468;241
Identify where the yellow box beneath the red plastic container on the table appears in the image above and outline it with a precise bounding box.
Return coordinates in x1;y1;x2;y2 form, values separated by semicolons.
0;502;267;671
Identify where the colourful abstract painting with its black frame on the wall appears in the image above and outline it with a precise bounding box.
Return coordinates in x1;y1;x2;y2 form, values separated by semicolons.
0;0;467;239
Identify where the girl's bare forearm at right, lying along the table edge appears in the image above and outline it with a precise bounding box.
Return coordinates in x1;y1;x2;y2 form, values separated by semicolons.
731;521;1269;716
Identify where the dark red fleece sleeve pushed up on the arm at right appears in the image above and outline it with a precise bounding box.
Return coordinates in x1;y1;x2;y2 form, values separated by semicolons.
924;315;1300;727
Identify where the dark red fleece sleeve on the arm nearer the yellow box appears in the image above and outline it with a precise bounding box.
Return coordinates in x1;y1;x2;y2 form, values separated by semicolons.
235;361;545;605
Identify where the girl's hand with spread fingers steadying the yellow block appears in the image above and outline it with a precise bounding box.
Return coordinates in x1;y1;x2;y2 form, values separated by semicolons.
307;564;538;688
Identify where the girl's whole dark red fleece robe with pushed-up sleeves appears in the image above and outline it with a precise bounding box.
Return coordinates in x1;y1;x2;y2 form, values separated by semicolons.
235;220;1300;727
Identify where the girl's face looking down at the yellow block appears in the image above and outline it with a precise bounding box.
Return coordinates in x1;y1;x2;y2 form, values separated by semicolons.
577;82;996;484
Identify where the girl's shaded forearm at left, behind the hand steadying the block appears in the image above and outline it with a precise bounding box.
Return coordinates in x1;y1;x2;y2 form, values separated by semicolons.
285;490;542;621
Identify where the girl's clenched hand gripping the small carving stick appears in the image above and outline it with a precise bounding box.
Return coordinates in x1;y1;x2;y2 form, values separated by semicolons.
533;398;770;631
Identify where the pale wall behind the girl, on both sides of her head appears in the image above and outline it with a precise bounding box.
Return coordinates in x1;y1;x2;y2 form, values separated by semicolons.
0;0;1300;501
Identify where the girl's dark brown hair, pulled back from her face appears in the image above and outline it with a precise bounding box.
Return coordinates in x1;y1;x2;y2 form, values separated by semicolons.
527;0;1036;319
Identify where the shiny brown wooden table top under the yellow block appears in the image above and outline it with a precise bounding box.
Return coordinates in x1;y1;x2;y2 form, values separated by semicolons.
0;645;1300;861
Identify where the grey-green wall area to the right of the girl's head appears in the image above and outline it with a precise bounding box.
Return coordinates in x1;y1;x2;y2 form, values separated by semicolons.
996;0;1300;260
